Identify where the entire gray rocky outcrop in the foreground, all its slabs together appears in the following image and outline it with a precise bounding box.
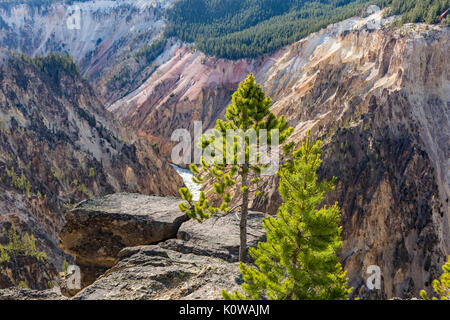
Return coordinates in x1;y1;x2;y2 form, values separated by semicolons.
53;194;265;300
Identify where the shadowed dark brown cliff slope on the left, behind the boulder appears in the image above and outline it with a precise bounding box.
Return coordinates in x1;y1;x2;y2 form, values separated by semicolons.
0;50;183;288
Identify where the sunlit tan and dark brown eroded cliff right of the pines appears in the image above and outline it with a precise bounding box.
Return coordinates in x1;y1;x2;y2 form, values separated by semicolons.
254;25;450;297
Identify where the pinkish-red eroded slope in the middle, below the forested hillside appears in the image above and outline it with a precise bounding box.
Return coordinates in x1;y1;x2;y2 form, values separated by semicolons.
108;43;257;157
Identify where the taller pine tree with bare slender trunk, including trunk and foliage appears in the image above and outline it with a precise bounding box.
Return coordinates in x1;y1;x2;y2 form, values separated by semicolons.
180;74;293;261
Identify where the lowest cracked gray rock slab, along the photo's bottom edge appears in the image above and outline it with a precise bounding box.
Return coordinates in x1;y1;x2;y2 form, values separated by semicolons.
73;245;241;300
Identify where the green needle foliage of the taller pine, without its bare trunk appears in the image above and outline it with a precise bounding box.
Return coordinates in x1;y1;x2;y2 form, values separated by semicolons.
180;75;293;222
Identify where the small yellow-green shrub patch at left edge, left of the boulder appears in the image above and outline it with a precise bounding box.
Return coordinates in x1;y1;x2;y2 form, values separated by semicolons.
0;228;47;262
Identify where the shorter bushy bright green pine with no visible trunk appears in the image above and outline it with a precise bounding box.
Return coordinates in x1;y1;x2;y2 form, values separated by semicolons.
223;134;352;300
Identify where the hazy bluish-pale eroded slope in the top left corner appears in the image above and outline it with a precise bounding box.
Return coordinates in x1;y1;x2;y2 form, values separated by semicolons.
0;0;172;103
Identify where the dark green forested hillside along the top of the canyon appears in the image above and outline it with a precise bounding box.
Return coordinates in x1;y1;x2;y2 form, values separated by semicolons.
166;0;449;59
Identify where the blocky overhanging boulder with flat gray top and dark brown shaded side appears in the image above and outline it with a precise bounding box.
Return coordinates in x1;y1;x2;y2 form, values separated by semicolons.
60;194;188;286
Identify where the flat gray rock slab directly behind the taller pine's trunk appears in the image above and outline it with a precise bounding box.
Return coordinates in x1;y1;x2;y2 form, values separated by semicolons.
160;212;266;262
